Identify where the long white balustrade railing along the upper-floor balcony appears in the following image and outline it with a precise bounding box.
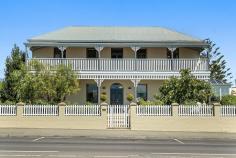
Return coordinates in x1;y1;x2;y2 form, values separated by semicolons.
27;58;208;72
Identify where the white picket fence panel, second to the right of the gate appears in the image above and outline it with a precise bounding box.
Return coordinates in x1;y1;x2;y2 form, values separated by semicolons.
178;105;213;116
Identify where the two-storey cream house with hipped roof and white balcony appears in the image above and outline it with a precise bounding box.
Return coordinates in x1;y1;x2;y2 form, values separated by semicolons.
26;27;210;104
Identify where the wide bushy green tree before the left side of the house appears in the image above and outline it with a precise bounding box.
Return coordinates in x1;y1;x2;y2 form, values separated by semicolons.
15;61;79;104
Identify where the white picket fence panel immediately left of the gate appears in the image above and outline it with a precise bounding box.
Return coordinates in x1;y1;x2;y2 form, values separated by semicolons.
65;105;101;116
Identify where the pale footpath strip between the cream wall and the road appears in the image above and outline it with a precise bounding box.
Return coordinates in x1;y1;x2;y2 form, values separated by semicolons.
0;128;236;139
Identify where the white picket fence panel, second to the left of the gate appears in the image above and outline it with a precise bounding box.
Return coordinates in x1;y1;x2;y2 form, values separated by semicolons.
23;105;59;116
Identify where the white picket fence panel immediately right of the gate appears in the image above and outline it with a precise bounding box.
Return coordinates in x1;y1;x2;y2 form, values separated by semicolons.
136;105;172;116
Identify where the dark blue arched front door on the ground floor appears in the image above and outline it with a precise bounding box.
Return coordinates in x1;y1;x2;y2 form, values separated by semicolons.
110;83;123;105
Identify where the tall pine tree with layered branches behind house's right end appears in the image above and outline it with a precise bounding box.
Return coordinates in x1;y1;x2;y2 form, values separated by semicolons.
202;39;232;83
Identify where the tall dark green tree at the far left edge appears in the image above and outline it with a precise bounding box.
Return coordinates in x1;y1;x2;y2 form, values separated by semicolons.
0;45;26;102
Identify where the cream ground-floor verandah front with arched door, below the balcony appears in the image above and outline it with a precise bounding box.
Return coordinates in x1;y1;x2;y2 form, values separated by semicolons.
67;79;164;105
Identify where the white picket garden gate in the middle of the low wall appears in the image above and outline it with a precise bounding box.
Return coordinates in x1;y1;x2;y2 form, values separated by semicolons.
107;105;130;128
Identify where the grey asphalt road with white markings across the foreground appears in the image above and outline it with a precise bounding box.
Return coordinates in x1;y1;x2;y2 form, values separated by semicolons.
0;137;236;158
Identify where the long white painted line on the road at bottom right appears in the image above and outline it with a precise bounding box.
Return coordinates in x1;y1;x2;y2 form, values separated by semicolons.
152;153;236;156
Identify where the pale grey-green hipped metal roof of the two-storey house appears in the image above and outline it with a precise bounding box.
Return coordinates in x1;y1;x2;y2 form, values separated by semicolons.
27;26;208;47
